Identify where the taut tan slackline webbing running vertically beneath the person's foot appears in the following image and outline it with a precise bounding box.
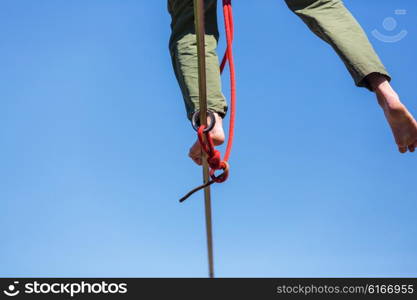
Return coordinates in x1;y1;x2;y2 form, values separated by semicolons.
194;0;214;278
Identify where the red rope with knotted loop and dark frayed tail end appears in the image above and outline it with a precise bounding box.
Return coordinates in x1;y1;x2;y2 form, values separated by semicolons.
180;0;236;202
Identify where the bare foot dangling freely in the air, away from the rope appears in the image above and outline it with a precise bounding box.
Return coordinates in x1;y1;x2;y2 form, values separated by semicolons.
369;74;417;153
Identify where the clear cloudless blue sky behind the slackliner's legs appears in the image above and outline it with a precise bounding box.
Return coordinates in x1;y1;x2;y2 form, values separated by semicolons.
0;0;417;277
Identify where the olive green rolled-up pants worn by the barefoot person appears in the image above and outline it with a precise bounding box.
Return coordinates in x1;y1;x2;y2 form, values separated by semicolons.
168;0;391;118
